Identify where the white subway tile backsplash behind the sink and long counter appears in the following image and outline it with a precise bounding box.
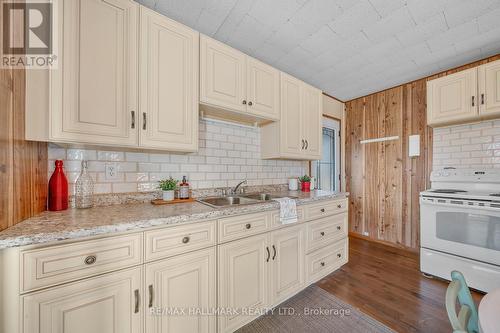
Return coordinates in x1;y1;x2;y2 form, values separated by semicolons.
49;120;308;193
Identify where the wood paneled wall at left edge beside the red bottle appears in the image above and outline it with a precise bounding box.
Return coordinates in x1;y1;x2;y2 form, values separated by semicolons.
0;69;48;230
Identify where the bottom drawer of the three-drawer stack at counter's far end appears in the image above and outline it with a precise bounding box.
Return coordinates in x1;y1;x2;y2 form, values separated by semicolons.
306;238;348;284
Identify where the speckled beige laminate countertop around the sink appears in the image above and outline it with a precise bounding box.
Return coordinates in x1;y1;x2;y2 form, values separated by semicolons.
0;191;347;249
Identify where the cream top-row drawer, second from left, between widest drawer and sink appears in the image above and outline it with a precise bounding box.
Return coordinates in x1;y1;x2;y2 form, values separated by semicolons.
145;221;216;261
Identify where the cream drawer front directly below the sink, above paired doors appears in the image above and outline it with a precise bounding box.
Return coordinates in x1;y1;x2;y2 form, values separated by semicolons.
219;213;271;243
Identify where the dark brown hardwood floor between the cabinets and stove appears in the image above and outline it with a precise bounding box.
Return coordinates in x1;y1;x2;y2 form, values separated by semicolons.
317;238;482;333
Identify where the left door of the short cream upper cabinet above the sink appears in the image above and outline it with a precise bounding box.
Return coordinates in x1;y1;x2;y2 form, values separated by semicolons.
200;35;247;112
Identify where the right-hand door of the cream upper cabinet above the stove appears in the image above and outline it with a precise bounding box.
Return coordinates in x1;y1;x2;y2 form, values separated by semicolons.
478;60;500;118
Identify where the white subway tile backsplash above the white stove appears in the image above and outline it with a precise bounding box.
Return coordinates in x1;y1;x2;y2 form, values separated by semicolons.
433;120;500;169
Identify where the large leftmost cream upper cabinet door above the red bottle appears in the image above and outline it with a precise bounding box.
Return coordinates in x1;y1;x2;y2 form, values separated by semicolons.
50;0;139;146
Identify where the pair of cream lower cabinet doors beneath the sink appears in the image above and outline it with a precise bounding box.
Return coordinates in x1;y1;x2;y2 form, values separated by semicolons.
219;225;305;332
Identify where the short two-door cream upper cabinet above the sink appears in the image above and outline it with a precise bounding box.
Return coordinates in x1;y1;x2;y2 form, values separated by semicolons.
200;35;280;123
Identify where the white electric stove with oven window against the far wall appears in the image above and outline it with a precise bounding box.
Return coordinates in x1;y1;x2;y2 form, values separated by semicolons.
420;168;500;292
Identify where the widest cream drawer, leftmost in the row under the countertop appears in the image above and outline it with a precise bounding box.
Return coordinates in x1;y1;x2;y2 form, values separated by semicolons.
21;234;142;291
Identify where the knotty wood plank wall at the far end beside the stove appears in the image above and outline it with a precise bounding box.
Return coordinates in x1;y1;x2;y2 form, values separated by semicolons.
345;55;500;250
